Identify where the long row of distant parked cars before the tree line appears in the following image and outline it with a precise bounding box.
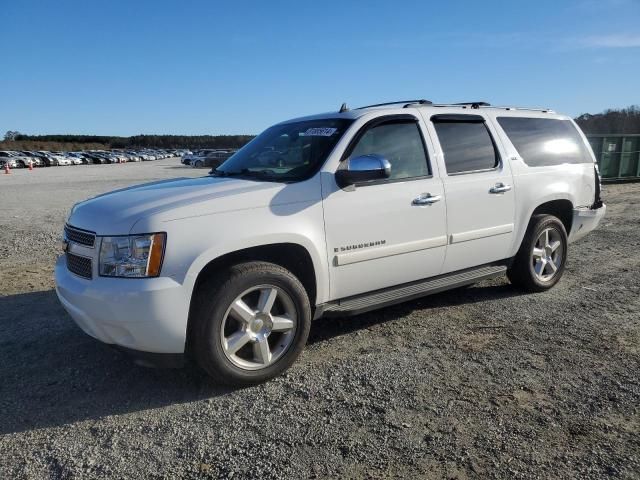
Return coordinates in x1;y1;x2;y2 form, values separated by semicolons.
0;149;190;168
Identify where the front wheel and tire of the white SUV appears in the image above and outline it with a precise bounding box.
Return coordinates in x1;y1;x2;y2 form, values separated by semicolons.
190;262;311;385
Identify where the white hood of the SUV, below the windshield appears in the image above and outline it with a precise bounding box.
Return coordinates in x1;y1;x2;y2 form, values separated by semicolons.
68;176;298;235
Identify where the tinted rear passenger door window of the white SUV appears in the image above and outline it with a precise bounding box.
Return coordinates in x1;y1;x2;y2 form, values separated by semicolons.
434;121;498;173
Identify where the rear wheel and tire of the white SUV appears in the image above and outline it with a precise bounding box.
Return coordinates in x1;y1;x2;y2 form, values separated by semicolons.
507;215;568;292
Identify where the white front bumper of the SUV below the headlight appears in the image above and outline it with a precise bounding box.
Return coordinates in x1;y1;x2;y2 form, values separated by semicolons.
55;255;189;354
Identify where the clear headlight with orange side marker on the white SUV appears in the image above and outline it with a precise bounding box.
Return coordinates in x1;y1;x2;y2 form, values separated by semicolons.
99;233;167;278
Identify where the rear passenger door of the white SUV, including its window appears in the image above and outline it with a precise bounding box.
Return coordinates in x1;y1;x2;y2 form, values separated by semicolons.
428;114;515;273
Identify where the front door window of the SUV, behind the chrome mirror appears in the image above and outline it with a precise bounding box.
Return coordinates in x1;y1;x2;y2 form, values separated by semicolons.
349;121;431;180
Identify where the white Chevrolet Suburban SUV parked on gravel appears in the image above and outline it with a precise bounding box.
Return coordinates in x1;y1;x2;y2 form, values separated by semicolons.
55;100;605;384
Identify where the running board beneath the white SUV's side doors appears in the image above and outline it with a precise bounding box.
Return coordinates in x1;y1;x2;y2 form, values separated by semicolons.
316;264;507;316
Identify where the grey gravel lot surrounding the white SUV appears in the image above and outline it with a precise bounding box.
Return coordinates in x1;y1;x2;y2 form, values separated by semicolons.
0;159;640;479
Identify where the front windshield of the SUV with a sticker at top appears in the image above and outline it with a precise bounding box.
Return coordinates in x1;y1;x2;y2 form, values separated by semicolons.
211;118;352;182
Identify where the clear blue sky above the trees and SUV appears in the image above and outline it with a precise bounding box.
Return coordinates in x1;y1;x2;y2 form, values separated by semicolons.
0;0;640;135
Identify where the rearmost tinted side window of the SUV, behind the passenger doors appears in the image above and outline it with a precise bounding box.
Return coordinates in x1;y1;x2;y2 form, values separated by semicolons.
498;117;592;167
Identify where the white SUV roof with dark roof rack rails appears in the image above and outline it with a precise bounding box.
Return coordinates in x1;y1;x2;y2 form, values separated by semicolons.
280;100;568;124
